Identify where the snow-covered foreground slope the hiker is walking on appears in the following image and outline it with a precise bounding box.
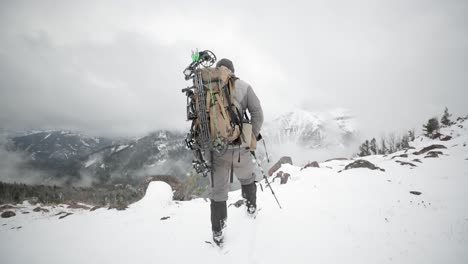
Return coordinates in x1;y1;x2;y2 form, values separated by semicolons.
0;118;468;264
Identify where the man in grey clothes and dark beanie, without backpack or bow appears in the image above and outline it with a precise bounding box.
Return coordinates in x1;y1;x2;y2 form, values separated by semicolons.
210;59;263;245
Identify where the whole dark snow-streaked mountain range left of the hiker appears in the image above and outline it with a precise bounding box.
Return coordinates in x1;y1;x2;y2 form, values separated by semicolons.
4;130;191;183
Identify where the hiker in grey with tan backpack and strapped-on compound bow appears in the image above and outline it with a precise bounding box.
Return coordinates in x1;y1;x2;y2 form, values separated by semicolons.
182;50;263;246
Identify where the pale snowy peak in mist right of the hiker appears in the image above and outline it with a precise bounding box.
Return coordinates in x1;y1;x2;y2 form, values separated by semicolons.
263;109;357;149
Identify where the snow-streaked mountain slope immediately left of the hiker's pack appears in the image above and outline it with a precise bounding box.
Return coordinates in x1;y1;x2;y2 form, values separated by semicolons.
83;131;192;184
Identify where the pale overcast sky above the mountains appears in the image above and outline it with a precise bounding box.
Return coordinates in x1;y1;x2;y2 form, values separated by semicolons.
0;0;468;136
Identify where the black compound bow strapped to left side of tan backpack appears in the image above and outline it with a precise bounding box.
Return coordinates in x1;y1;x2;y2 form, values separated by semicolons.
182;50;216;176
